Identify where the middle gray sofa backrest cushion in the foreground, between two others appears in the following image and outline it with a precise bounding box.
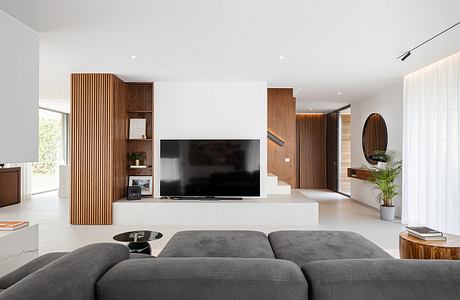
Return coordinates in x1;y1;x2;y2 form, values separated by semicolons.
97;257;308;300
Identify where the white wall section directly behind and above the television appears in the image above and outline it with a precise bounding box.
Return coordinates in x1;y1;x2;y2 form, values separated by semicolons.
153;82;267;197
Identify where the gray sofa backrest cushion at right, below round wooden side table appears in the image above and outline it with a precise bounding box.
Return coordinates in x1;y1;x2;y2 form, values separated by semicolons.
302;259;460;300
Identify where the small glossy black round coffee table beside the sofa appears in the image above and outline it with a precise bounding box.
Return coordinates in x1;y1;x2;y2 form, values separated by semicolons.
113;230;163;255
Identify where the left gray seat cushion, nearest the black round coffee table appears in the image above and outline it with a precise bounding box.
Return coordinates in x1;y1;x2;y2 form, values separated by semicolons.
158;230;275;258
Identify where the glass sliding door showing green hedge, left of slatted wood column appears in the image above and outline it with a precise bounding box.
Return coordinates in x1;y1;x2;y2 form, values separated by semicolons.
32;108;68;194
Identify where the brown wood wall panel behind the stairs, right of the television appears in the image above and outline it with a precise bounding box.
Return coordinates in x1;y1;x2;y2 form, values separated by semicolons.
267;88;296;187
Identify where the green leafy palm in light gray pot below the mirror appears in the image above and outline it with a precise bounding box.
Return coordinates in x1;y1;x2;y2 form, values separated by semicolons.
368;150;402;221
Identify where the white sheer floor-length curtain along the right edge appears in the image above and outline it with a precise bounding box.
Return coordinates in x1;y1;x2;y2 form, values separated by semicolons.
402;53;460;234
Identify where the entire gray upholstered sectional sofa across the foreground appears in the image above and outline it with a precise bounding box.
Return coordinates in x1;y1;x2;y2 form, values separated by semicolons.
0;231;460;300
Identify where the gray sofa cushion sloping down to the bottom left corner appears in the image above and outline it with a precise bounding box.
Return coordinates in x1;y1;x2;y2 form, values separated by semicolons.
0;243;129;300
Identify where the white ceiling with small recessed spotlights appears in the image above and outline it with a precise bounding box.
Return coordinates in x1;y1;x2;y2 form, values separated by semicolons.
0;0;460;112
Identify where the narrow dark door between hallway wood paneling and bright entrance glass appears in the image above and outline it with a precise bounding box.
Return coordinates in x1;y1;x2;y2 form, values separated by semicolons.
326;111;339;192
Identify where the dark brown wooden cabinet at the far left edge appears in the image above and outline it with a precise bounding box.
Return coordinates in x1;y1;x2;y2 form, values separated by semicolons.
0;168;21;207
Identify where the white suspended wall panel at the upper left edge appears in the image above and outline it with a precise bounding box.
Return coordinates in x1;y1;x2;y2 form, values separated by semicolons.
0;11;39;163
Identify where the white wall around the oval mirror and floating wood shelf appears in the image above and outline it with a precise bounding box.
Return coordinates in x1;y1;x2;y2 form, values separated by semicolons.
351;80;403;216
